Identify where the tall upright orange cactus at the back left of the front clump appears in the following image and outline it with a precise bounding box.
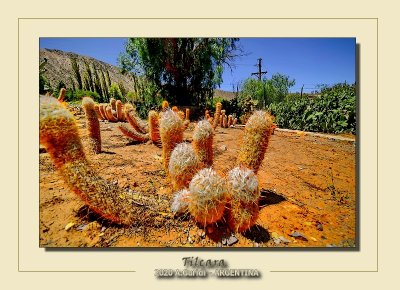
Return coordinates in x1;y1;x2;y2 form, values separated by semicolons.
160;110;183;174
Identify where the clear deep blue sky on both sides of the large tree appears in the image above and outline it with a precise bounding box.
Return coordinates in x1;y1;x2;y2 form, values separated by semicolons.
40;38;356;92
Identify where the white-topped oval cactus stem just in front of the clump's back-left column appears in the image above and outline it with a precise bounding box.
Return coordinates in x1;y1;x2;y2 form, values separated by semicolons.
168;143;200;190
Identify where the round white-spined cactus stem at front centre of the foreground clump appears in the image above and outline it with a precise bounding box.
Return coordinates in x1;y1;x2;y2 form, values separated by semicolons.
189;168;227;226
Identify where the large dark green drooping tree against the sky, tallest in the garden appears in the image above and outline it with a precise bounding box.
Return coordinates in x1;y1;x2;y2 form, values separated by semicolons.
119;38;239;105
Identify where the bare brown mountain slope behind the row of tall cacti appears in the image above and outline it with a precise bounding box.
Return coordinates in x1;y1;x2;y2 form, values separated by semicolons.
39;49;133;91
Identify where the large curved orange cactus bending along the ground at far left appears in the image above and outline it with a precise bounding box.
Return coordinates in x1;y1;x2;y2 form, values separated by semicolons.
39;97;135;225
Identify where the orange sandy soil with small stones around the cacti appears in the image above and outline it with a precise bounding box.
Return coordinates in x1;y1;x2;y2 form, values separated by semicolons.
39;115;356;248
